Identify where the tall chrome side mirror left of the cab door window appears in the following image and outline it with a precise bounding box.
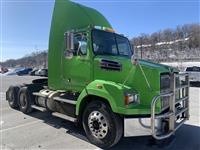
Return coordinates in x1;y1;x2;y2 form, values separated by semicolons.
64;32;74;59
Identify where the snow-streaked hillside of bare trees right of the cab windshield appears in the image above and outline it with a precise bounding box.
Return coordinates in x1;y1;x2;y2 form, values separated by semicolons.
131;24;200;61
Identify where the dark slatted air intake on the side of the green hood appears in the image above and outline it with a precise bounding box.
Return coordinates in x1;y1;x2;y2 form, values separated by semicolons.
100;59;122;71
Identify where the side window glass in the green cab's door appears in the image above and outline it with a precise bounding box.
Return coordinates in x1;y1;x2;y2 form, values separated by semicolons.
73;33;87;56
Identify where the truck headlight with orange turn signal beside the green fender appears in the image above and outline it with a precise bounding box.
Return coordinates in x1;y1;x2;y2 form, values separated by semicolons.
124;93;140;105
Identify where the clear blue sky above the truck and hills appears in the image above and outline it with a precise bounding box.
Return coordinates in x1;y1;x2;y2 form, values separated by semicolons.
0;0;200;61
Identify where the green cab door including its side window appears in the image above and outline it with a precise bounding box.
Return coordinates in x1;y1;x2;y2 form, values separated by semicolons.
62;32;92;91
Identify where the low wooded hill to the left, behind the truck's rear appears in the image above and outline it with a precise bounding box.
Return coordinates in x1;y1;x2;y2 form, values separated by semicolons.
0;50;48;68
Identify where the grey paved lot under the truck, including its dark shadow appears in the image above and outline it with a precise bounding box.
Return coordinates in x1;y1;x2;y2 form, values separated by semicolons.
0;76;200;150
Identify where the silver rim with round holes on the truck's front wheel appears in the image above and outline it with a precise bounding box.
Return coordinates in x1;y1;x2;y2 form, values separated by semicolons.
88;111;108;139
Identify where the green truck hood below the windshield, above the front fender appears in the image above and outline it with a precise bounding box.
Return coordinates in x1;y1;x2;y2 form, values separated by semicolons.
94;55;178;108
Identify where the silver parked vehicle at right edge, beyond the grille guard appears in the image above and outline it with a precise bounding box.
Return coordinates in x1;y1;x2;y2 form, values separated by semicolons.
185;66;200;82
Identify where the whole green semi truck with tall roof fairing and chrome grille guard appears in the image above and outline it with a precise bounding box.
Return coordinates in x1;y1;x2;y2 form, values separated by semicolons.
6;0;189;148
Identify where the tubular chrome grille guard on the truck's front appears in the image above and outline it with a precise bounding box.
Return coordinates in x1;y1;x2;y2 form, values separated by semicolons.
151;73;189;140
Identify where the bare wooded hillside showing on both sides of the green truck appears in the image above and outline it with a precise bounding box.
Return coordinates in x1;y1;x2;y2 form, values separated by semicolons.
0;24;200;67
